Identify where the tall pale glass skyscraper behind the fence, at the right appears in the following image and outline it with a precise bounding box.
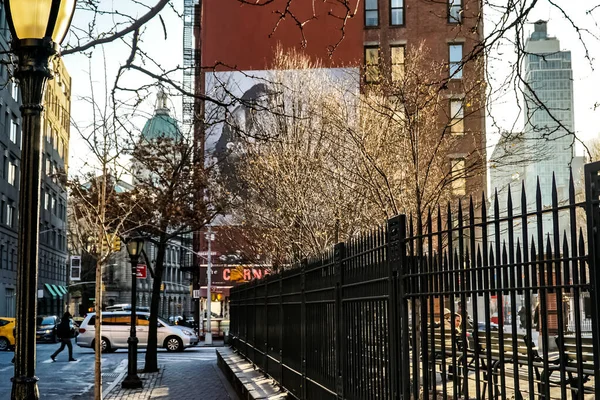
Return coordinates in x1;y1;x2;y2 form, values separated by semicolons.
523;21;582;212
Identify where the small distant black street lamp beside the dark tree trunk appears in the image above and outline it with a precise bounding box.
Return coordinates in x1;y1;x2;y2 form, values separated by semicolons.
121;237;144;389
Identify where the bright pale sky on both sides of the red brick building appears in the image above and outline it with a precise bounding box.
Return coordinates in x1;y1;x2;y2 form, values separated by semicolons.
59;0;600;172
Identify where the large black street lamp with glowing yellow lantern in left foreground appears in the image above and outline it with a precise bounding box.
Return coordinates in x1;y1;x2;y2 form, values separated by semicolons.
4;0;76;400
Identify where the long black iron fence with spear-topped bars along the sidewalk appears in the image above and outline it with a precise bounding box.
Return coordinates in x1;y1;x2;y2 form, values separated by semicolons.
230;163;600;399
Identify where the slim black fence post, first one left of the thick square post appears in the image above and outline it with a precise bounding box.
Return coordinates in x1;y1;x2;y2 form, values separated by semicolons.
333;243;346;399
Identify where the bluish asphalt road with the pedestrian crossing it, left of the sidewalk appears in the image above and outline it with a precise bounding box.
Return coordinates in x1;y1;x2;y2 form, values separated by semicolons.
0;343;232;400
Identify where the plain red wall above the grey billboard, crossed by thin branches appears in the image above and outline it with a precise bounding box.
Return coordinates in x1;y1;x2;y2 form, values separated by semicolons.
202;0;363;70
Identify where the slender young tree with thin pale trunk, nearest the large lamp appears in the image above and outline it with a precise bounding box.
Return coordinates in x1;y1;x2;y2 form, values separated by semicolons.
68;69;143;399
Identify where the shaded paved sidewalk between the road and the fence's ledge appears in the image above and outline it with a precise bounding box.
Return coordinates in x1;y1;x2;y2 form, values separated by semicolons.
103;342;238;400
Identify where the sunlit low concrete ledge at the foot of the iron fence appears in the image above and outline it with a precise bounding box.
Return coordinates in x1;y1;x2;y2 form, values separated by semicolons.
216;347;288;400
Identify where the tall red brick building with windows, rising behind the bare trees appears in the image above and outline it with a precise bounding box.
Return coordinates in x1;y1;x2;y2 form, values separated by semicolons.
195;0;486;322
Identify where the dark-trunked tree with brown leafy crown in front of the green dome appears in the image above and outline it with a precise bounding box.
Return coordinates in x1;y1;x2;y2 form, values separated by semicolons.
118;127;222;372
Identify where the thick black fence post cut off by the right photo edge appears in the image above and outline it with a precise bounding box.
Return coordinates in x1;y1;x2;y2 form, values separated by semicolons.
580;162;600;388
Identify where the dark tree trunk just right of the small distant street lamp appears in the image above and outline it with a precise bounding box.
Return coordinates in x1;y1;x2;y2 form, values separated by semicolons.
144;233;167;372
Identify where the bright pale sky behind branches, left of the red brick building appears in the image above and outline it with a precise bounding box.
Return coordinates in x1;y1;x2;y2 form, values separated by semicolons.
63;0;183;175
